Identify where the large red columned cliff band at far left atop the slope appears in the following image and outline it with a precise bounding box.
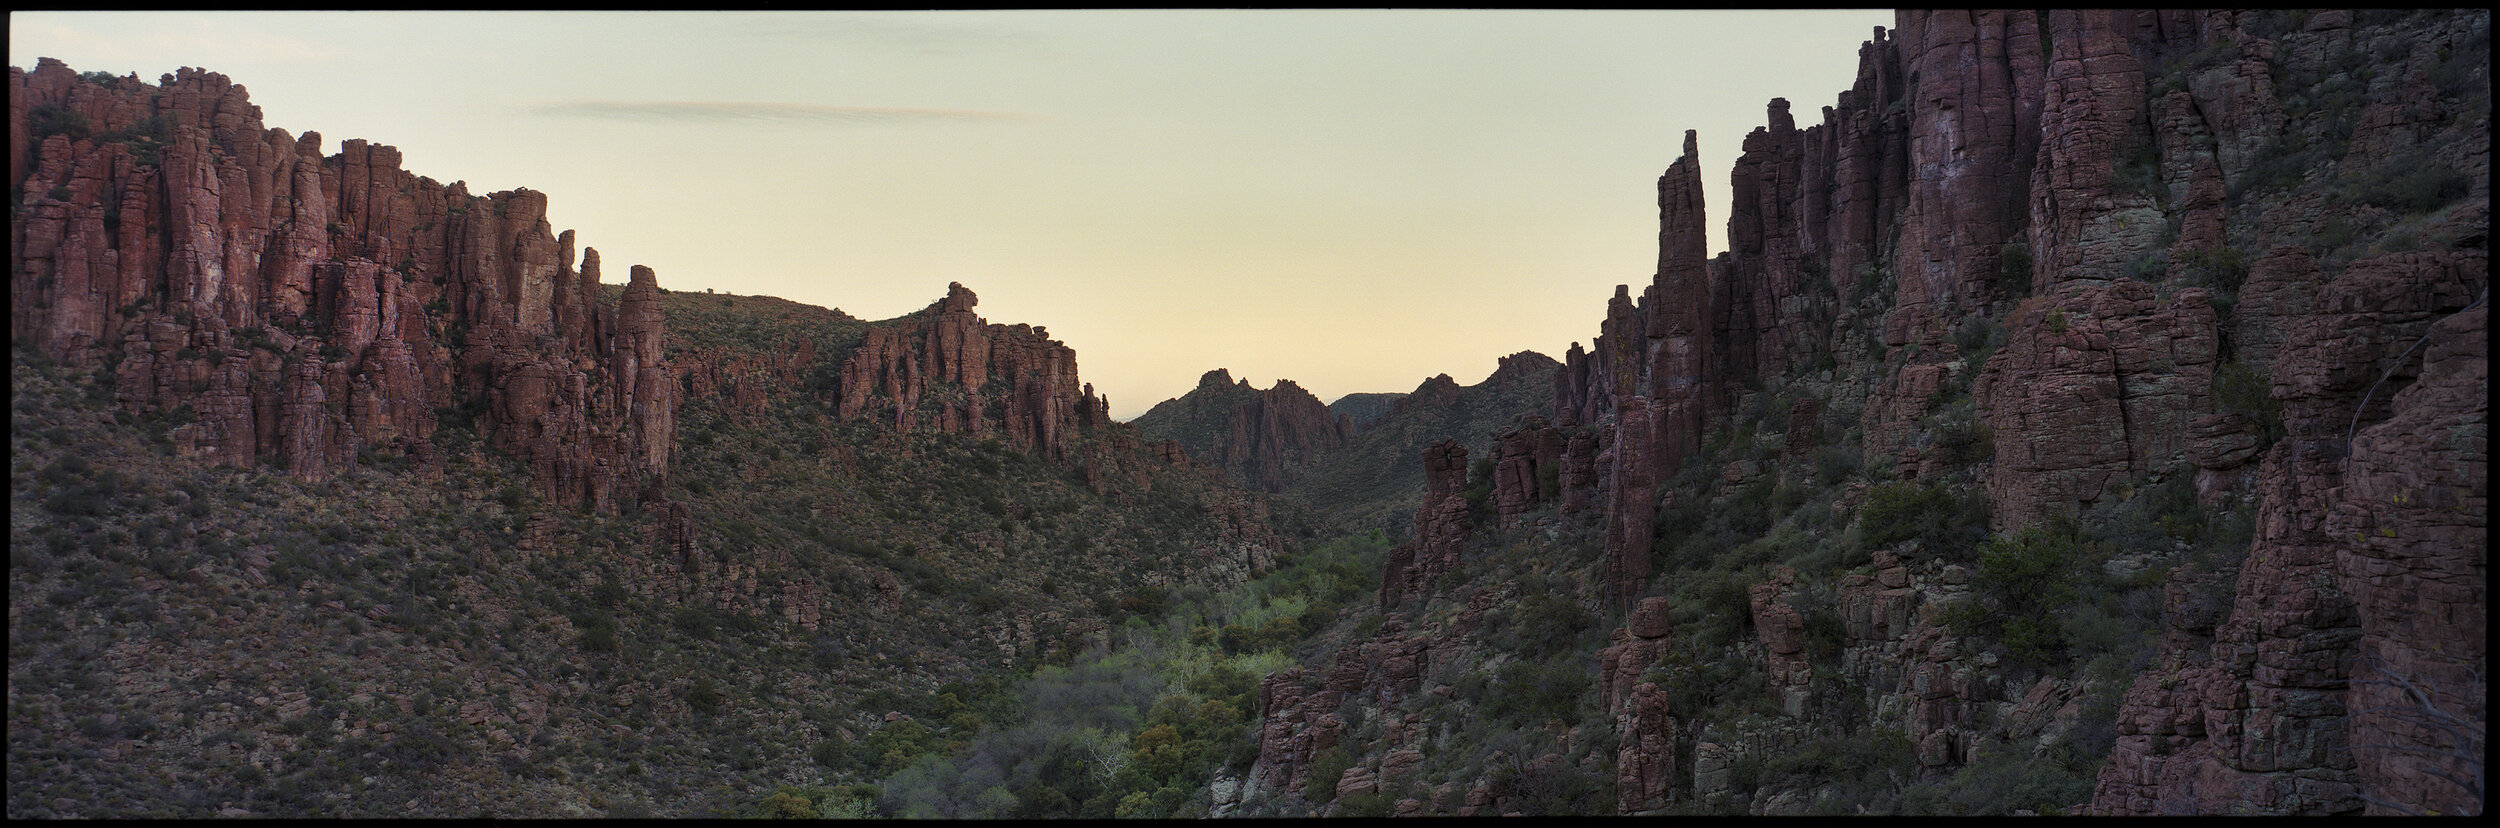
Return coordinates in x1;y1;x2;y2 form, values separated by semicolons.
10;60;675;510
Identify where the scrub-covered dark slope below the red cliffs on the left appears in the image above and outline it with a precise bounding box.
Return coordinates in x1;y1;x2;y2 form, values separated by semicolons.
10;283;1293;818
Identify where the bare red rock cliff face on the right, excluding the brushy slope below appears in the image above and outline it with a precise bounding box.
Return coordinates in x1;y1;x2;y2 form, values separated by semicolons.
1513;10;2490;813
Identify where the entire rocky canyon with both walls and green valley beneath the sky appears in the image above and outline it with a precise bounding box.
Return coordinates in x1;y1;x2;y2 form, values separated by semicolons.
10;10;2490;818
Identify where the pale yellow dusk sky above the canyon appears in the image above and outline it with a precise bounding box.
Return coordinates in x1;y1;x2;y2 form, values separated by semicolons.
10;10;1893;420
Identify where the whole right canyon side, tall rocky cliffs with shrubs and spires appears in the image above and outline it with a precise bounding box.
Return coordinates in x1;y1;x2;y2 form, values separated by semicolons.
1250;10;2490;813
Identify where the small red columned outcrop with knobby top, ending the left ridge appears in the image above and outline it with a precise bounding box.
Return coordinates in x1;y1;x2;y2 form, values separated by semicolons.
835;285;1110;460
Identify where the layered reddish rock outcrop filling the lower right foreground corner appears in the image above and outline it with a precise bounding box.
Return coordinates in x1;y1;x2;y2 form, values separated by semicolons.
2093;250;2490;813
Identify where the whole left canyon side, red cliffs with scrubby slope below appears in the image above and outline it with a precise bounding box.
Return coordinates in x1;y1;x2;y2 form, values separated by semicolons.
10;63;1310;818
